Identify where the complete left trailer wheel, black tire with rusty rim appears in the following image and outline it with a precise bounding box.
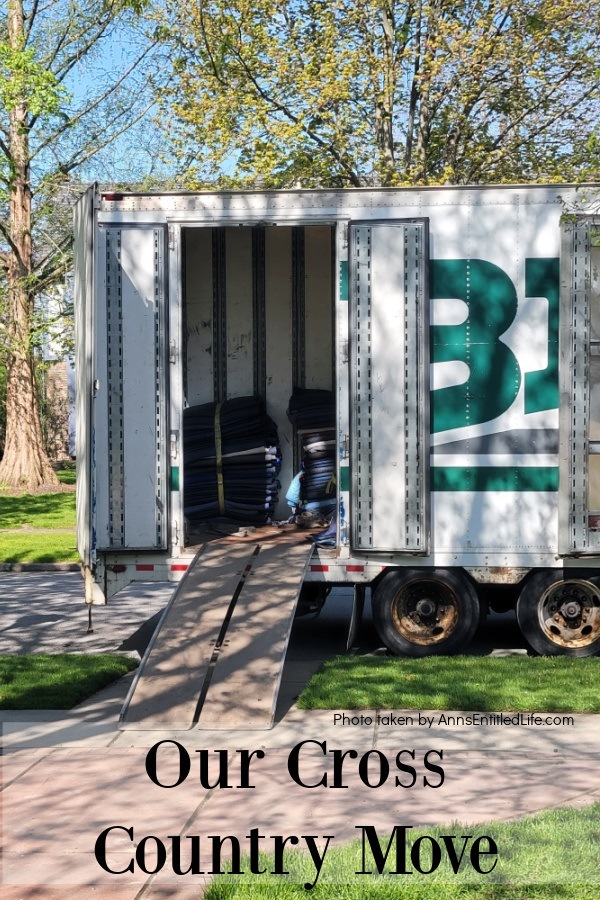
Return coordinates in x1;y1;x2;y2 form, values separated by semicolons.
372;569;480;656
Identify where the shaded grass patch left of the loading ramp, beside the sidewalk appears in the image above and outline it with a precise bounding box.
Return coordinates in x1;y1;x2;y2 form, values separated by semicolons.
0;653;138;709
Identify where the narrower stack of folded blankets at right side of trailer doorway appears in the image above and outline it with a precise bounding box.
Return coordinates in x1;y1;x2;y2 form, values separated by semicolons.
288;388;336;514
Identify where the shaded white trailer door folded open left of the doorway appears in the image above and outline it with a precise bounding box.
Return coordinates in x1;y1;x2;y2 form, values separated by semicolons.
93;227;168;551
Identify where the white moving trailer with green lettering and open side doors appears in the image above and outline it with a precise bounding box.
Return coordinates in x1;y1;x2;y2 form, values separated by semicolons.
76;185;600;656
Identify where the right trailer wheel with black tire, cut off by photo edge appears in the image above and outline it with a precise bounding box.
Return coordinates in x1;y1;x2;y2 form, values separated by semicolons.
517;569;600;656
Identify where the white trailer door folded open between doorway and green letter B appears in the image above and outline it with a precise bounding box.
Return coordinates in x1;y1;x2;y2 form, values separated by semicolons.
349;220;429;554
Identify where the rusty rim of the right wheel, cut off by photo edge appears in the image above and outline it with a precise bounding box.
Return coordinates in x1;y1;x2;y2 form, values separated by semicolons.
538;580;600;649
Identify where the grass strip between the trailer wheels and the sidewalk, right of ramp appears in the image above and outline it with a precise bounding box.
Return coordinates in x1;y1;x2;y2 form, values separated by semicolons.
298;656;600;713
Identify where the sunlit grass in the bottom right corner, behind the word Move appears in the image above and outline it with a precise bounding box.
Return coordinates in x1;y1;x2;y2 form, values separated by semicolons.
204;803;600;900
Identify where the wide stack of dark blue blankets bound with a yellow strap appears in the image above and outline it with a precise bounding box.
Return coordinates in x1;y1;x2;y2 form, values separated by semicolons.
183;397;281;525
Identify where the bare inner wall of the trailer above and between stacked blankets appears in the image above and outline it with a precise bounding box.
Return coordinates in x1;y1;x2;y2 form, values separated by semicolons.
182;224;336;519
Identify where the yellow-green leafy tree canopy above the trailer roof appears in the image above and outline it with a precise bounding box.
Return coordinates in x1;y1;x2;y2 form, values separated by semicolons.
157;0;600;187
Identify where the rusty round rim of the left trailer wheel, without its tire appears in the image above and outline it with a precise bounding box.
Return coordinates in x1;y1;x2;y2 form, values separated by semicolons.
392;579;459;646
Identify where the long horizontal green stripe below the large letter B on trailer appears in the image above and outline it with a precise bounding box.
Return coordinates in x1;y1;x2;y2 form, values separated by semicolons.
431;466;558;491
